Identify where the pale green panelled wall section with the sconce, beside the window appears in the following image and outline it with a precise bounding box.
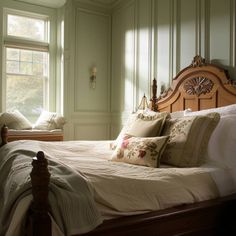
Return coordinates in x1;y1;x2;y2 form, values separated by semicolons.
64;0;111;140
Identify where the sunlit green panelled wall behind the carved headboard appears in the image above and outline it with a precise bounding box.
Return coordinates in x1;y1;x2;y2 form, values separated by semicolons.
111;0;236;137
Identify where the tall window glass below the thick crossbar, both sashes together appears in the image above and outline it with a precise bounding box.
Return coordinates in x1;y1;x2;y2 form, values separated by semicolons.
6;48;48;122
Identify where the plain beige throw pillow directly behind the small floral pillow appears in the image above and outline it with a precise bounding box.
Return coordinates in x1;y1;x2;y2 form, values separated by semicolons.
110;110;169;149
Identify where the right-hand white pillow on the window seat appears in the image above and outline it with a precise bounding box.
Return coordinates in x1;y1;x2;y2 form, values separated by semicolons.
34;111;66;130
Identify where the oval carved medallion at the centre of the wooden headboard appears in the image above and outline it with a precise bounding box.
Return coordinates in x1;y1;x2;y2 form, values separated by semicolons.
183;77;214;96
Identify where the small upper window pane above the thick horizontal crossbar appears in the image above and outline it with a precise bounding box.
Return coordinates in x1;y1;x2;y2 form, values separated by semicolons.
7;14;46;41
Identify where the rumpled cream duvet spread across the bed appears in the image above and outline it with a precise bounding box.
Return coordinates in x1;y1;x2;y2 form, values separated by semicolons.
0;141;236;236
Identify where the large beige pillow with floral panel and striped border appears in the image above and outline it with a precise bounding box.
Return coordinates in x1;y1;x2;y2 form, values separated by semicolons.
162;112;220;167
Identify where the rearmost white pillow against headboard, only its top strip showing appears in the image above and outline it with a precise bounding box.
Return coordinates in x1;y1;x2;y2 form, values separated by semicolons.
184;104;236;116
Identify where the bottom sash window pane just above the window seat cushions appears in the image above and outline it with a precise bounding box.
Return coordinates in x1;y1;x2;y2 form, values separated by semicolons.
6;75;44;123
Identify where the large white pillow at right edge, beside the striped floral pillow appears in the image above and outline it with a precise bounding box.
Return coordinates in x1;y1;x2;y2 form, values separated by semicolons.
208;114;236;168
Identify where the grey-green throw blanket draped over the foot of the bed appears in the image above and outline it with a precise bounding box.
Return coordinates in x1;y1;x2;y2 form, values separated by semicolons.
0;141;102;235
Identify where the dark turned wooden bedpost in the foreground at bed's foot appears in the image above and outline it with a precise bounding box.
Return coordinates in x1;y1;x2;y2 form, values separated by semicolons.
28;151;51;236
